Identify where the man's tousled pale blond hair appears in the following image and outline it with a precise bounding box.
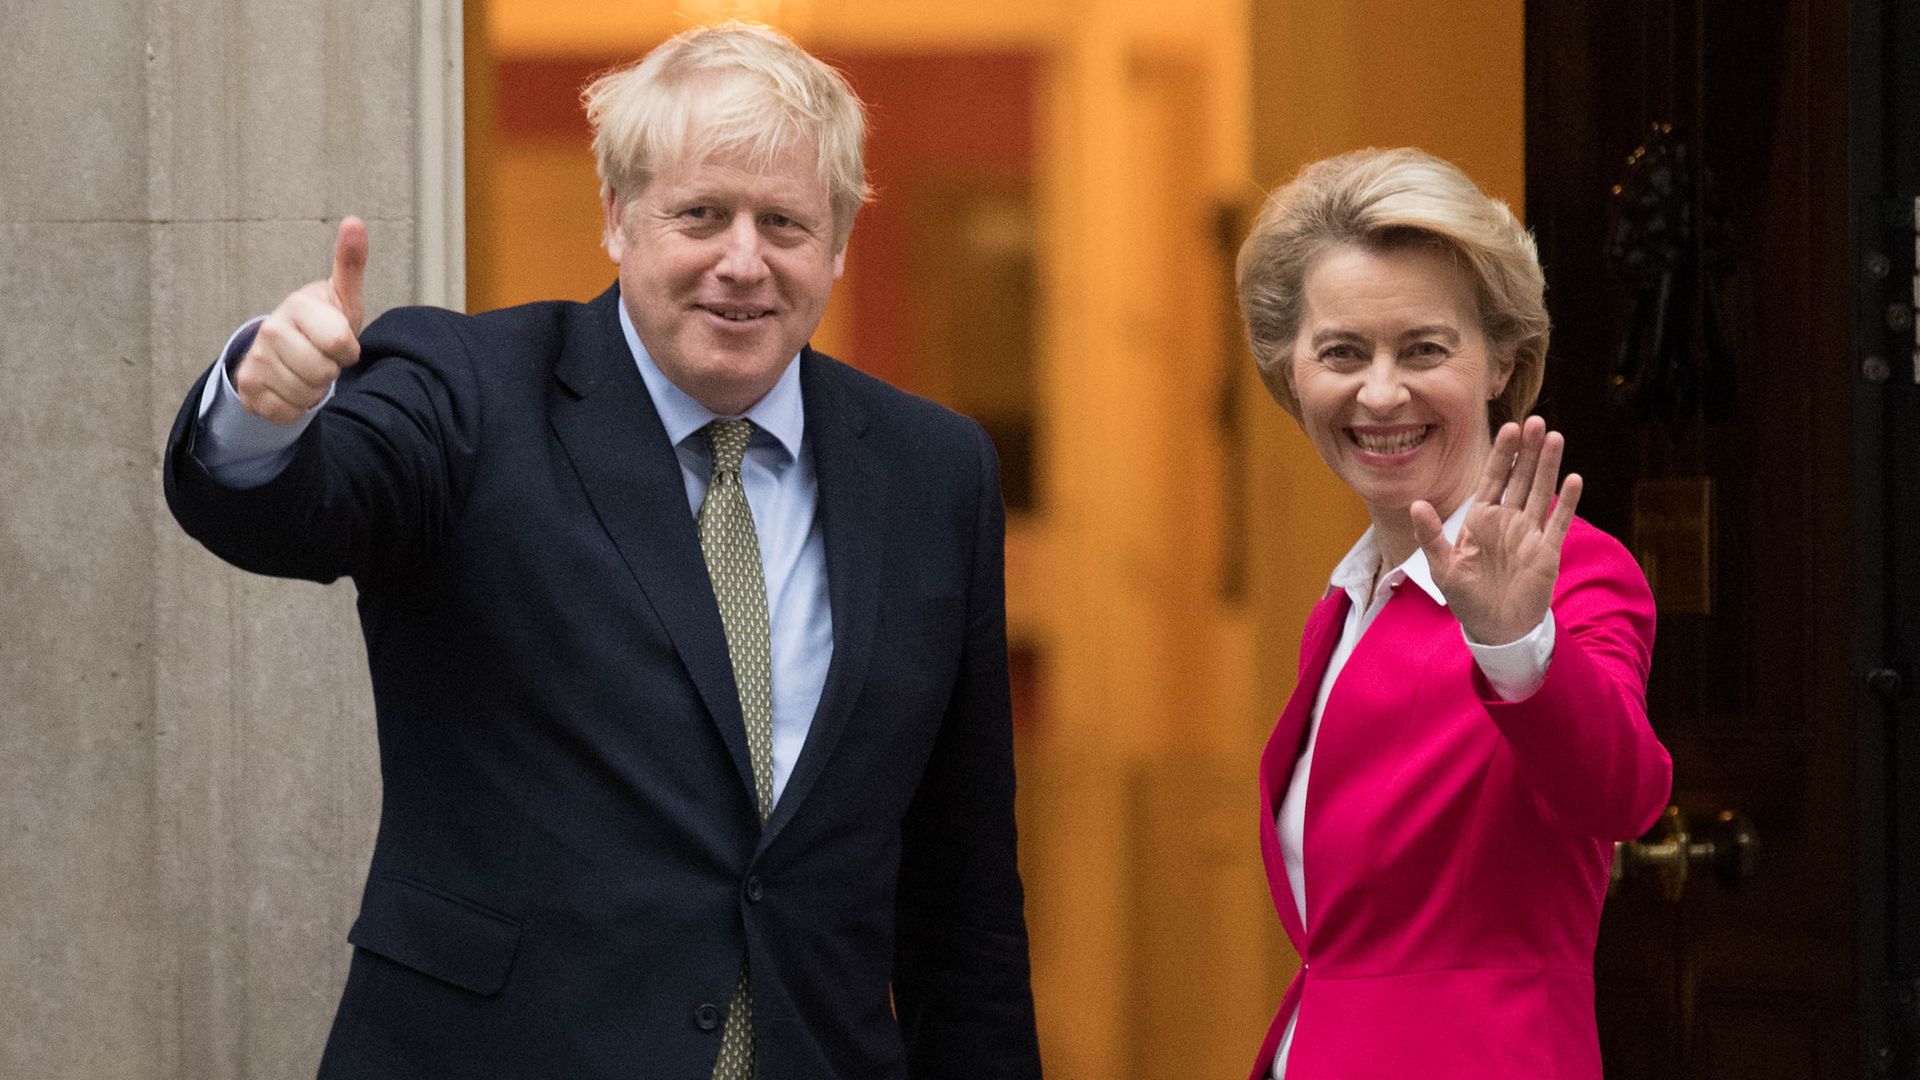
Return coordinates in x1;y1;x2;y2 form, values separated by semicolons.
580;23;872;250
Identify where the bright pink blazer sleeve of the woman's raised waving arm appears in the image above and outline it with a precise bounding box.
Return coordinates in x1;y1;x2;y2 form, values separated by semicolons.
1473;521;1672;840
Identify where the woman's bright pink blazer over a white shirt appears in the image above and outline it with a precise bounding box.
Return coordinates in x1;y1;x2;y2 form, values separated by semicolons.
1254;519;1672;1080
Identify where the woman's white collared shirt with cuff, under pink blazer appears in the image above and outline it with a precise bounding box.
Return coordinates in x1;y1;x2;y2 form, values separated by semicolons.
1273;500;1553;1080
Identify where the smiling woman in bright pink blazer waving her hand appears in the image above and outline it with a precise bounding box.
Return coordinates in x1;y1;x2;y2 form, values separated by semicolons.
1238;150;1672;1080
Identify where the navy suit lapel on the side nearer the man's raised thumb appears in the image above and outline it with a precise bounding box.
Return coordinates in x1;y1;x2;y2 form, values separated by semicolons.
547;286;753;792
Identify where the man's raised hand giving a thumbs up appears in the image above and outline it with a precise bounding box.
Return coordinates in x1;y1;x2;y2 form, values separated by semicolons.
230;217;367;425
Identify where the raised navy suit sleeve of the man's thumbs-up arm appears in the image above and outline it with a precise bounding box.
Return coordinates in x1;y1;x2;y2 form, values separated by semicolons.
165;307;480;582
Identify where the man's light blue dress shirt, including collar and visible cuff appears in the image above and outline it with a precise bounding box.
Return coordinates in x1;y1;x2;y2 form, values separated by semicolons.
194;290;833;803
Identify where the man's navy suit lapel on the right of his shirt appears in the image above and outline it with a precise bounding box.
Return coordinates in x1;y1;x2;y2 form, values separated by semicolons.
760;348;887;851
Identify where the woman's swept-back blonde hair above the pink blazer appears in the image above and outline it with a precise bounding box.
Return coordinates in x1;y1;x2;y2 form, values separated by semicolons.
1235;148;1549;427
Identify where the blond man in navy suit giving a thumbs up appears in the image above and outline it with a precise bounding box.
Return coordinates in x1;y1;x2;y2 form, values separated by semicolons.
167;25;1039;1080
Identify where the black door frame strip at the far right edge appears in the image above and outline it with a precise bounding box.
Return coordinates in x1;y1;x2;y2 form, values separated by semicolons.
1847;0;1920;1078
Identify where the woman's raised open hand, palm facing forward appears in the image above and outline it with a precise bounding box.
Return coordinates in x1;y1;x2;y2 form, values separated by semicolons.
1411;417;1580;646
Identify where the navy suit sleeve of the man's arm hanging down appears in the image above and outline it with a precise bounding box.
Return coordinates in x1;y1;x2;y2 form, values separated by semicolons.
893;427;1041;1080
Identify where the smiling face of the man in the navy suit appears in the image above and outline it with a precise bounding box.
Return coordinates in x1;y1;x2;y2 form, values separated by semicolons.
605;148;845;415
